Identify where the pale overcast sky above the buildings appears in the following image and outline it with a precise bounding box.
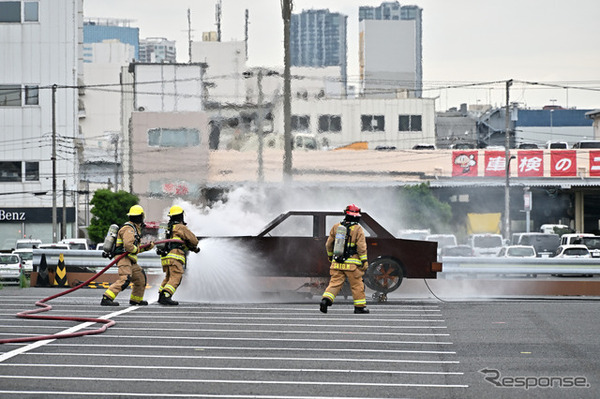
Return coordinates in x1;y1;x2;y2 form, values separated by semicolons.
84;0;600;110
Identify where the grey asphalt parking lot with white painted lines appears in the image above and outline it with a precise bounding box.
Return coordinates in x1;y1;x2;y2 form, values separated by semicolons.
0;288;600;398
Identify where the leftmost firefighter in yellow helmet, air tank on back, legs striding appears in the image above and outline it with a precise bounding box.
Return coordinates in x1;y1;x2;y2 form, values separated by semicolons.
100;205;154;306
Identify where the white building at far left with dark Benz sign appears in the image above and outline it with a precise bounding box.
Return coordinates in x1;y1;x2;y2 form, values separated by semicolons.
0;0;83;248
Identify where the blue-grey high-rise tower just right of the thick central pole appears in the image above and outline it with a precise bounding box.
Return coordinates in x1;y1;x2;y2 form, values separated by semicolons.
290;10;348;96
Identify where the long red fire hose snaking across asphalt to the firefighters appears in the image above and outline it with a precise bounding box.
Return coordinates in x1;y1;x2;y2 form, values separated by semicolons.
0;240;181;344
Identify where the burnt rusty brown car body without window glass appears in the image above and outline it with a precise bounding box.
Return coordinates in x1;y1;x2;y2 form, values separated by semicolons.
198;211;441;296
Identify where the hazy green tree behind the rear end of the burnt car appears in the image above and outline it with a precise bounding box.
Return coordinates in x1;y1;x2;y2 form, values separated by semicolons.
401;183;452;232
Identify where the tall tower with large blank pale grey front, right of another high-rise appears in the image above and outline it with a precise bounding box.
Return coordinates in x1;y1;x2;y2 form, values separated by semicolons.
358;1;423;97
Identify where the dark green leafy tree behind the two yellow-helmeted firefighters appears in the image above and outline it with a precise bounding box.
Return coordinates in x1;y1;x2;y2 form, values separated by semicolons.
88;189;139;242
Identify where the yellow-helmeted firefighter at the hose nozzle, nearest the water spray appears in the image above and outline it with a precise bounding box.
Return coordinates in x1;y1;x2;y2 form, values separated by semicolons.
158;205;200;305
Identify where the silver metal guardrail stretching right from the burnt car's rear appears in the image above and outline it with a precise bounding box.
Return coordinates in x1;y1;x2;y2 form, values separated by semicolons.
442;257;600;275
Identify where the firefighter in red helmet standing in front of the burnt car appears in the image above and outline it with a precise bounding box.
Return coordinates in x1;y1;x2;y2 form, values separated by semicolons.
320;204;369;313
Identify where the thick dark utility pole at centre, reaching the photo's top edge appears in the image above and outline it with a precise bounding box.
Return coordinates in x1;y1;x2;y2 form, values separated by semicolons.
281;0;293;182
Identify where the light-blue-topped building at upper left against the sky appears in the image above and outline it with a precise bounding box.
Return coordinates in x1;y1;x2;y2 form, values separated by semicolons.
83;18;140;62
